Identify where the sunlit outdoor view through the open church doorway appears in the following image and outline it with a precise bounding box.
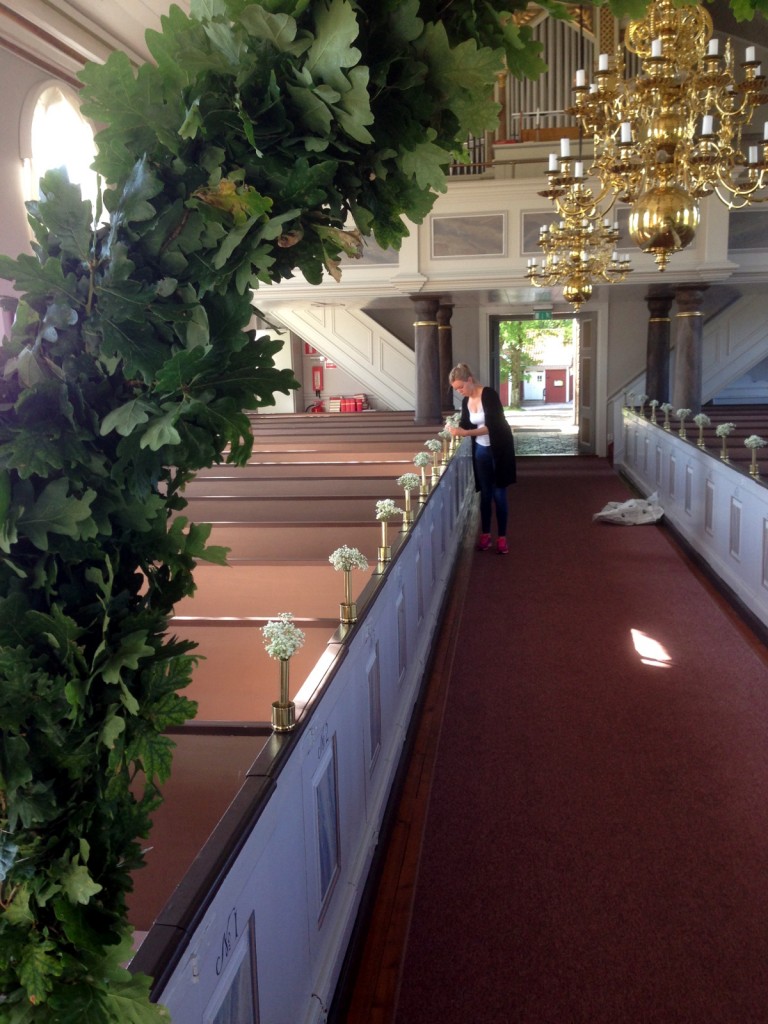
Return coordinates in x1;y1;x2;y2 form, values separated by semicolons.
490;316;580;456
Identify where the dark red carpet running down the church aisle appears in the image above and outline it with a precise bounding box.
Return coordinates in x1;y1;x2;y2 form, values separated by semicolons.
396;458;768;1024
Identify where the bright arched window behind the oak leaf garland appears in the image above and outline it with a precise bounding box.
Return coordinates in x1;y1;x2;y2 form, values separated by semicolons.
19;82;97;216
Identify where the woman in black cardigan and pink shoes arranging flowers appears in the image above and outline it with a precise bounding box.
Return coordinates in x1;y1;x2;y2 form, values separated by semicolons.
449;362;517;555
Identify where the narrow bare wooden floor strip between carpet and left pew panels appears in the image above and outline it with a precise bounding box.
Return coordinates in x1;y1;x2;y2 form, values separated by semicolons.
329;505;476;1024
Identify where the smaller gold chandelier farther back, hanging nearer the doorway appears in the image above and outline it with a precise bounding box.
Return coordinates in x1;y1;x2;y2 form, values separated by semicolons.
526;146;632;312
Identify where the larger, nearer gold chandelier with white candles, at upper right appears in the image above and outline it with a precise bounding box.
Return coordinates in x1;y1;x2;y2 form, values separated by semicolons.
548;0;768;270
